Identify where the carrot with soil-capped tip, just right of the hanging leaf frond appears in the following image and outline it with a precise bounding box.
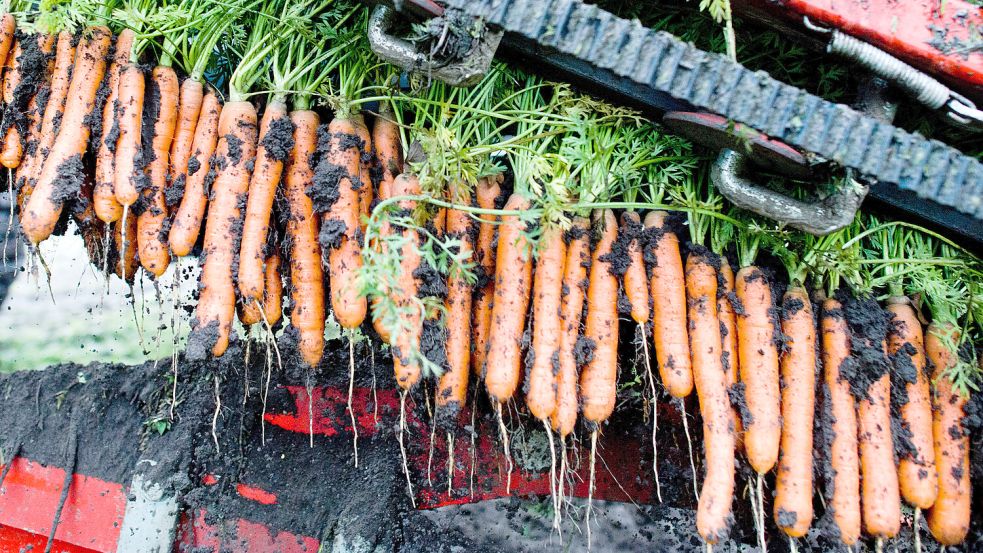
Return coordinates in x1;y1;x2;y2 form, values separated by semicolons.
437;183;474;421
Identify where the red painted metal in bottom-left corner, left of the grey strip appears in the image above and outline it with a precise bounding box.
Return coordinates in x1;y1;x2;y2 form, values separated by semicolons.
0;457;126;553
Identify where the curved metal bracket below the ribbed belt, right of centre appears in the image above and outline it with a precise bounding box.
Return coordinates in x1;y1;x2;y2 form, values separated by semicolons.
710;149;869;236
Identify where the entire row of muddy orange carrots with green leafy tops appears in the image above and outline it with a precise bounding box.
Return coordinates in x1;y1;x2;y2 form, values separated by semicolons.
0;0;983;546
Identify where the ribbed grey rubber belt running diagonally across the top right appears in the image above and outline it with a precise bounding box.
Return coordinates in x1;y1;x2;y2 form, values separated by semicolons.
445;0;983;229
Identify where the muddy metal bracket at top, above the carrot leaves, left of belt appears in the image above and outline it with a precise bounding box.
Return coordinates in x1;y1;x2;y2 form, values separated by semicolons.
368;5;504;86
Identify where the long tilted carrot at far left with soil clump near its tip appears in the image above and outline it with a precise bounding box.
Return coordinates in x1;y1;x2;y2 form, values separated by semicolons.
21;27;110;244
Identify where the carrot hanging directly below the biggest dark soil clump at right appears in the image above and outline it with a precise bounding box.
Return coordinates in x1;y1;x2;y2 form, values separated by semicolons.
857;343;901;538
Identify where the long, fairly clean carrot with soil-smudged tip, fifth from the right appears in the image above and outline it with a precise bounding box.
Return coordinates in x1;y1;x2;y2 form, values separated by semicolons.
774;286;816;538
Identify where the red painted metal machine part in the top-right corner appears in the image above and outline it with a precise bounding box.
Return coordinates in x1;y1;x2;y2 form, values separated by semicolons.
734;0;983;98
